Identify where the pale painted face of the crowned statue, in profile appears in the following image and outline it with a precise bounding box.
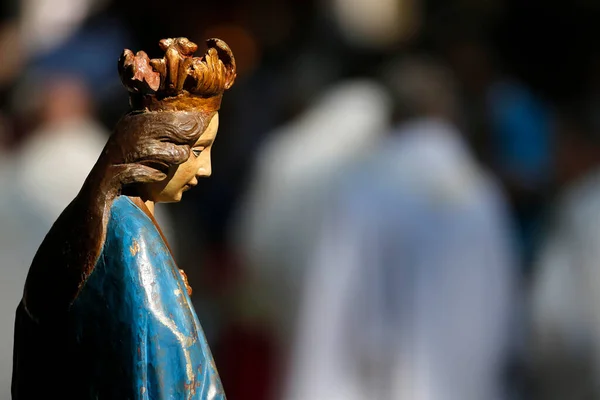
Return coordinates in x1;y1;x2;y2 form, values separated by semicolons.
145;113;219;203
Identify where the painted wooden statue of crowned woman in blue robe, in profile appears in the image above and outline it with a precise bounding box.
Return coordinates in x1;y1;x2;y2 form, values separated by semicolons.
12;38;236;400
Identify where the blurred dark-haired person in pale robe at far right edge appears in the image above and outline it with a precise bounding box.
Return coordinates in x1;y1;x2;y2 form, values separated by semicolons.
530;105;600;400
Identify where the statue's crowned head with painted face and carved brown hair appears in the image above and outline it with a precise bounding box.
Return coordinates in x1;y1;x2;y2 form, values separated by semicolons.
116;38;236;202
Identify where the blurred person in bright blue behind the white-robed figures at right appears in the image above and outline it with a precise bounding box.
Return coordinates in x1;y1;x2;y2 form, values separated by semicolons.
443;32;554;273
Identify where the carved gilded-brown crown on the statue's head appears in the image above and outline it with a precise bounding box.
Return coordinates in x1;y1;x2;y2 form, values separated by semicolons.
119;37;236;111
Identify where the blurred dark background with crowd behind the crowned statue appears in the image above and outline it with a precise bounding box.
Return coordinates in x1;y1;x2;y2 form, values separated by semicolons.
0;0;600;400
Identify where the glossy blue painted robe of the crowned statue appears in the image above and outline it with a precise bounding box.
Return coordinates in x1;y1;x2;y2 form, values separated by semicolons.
15;196;225;400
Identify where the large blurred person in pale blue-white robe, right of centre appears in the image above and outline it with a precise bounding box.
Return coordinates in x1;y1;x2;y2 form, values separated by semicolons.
282;57;518;400
